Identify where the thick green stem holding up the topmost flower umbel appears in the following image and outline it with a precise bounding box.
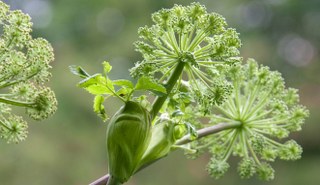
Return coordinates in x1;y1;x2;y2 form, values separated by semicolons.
151;61;186;118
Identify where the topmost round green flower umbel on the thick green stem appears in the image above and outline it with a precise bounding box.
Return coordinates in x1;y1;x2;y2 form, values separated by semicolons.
130;3;241;90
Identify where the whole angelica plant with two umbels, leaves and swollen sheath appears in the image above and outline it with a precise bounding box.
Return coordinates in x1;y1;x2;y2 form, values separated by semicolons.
70;3;308;185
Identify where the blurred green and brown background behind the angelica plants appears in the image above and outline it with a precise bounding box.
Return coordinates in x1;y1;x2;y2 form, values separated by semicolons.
0;0;320;185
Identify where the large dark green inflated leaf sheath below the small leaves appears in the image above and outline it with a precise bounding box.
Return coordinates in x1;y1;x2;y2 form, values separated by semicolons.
107;101;151;183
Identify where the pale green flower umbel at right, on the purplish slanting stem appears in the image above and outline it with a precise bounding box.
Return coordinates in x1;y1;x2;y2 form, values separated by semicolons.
195;59;309;180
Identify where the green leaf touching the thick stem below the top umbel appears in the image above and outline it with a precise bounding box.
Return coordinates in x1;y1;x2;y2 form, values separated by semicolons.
135;77;167;96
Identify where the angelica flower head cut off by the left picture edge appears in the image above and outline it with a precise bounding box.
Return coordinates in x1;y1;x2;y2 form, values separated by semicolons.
0;1;57;143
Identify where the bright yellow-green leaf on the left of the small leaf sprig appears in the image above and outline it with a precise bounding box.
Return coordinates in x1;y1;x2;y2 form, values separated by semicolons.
78;74;114;95
